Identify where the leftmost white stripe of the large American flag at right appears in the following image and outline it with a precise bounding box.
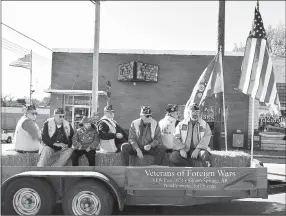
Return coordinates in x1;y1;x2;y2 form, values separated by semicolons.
242;38;257;94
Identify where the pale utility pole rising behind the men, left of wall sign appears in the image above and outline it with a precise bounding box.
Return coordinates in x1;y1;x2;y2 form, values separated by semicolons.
92;1;100;116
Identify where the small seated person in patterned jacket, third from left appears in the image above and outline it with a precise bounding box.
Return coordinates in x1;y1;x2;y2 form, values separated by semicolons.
71;116;99;166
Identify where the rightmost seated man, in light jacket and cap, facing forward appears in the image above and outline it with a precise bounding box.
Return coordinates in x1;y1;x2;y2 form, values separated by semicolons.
170;104;212;167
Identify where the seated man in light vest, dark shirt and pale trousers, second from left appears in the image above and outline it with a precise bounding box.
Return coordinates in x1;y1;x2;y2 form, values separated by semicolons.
37;108;74;167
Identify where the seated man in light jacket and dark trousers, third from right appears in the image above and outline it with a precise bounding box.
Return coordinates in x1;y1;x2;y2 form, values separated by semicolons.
121;106;166;166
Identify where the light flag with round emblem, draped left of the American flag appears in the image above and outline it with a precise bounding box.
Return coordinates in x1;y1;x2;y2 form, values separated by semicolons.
184;50;224;118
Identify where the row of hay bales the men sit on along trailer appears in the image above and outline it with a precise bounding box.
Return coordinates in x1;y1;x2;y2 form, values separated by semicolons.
1;150;250;167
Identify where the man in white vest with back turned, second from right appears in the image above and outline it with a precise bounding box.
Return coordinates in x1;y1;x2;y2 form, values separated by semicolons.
159;104;180;152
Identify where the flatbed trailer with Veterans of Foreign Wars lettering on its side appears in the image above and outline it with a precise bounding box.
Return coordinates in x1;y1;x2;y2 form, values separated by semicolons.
1;166;274;215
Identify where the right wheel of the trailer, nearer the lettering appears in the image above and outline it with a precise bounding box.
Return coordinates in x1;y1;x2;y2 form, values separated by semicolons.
62;180;114;215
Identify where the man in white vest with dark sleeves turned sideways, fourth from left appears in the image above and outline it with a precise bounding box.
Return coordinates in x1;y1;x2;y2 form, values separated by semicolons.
97;105;128;153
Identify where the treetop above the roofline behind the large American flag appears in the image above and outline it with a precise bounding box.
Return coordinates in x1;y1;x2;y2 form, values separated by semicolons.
233;24;286;58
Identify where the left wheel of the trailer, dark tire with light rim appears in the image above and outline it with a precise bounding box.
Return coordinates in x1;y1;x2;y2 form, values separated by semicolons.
2;178;56;215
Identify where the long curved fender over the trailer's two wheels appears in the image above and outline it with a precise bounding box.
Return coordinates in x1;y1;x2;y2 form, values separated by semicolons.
1;171;124;211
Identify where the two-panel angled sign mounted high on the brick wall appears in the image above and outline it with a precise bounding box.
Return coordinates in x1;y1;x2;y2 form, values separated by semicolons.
118;61;159;82
